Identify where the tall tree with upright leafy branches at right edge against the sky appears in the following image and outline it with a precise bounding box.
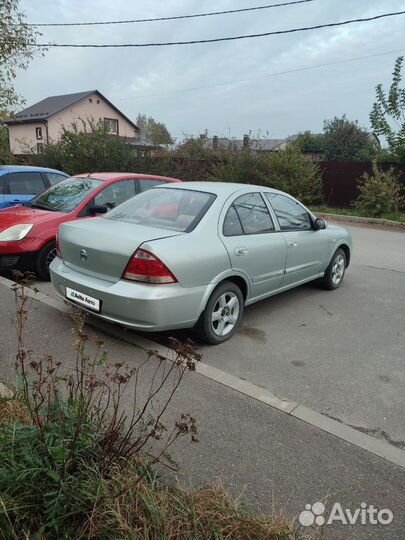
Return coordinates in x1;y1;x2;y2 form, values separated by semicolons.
370;56;405;162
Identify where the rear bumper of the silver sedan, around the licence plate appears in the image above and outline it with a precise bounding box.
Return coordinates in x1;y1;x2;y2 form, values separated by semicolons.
50;257;209;332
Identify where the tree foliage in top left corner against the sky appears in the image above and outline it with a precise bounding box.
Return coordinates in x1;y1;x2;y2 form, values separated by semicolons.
0;0;40;110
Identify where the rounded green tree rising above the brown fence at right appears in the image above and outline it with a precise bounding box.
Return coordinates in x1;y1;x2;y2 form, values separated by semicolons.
323;115;378;161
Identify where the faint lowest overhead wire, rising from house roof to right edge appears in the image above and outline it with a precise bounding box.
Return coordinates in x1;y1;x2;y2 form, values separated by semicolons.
113;49;403;101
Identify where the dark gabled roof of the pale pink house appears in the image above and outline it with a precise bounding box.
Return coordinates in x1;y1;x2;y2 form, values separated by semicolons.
3;90;139;131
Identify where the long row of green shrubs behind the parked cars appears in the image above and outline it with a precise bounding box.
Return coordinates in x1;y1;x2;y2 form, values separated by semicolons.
31;122;322;204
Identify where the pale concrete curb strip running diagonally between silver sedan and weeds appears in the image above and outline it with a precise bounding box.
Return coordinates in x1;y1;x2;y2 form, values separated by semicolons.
0;276;405;468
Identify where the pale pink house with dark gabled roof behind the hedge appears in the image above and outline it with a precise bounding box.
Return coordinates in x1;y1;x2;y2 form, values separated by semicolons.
3;90;140;155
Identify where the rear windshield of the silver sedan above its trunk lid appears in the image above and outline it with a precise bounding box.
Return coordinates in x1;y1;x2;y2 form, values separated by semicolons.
104;188;215;232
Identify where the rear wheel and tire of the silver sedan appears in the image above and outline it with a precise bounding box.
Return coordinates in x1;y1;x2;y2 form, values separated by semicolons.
197;281;244;345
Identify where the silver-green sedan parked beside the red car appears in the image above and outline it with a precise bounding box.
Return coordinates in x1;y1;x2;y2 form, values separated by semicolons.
50;182;352;344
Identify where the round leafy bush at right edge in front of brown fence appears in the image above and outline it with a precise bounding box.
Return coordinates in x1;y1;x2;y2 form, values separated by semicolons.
353;162;405;217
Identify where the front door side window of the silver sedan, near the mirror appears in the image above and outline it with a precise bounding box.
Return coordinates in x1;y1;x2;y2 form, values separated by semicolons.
265;193;312;231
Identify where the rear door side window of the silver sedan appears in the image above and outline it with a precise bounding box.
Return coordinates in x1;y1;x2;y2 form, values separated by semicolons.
223;193;274;236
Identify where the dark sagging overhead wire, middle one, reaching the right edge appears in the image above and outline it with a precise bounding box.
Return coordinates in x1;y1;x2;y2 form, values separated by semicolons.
19;11;405;49
